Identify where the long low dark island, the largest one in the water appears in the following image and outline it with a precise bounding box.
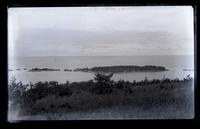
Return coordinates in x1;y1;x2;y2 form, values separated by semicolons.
73;65;168;73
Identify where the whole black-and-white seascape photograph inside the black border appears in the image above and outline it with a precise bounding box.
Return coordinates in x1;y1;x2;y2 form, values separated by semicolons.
8;6;195;122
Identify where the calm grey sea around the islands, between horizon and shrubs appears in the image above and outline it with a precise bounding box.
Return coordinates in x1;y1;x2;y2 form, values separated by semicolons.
8;56;194;83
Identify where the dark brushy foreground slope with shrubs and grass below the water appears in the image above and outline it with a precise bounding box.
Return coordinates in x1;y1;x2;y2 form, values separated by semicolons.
9;73;193;116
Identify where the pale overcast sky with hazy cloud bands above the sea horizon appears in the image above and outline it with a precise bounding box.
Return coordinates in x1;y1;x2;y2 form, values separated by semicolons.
8;6;194;56
